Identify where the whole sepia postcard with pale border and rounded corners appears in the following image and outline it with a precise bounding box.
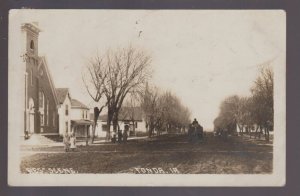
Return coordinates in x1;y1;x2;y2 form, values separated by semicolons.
7;9;286;186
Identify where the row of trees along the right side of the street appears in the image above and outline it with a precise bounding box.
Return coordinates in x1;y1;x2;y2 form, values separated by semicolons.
214;65;274;141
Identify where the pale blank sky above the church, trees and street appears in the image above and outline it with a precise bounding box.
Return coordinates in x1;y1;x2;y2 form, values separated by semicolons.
10;10;285;128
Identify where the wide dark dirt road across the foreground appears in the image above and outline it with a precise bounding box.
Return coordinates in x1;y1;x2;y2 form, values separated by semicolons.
20;134;273;174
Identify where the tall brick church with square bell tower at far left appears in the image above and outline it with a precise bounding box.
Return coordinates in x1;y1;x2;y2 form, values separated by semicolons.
21;23;58;134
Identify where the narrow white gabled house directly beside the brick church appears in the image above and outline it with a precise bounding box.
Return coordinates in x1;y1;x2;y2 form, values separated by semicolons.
56;88;71;135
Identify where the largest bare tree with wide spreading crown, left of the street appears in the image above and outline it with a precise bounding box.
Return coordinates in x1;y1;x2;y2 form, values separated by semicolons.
82;46;151;140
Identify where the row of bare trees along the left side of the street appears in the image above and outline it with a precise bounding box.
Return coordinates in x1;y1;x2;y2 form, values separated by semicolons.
82;46;190;142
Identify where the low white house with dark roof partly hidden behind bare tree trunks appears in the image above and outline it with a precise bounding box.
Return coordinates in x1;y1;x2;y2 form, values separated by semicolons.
90;107;147;137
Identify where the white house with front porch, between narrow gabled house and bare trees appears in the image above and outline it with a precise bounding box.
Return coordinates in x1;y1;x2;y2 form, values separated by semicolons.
71;99;93;137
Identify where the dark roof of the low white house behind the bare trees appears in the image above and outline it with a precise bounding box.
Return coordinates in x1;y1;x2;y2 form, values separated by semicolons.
96;107;143;121
